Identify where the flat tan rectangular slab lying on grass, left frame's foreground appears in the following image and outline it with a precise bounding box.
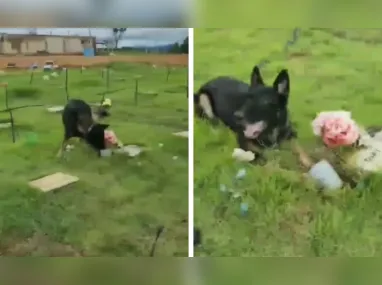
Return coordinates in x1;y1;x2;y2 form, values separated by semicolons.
29;172;79;192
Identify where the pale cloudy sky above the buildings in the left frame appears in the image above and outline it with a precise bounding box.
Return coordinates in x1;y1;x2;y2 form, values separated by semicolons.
0;28;188;46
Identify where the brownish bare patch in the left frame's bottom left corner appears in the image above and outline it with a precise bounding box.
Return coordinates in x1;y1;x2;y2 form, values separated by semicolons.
0;234;83;257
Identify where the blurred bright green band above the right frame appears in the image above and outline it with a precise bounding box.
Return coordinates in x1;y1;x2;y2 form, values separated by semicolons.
195;0;380;29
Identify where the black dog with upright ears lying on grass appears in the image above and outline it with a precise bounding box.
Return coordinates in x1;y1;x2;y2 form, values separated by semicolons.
194;66;296;161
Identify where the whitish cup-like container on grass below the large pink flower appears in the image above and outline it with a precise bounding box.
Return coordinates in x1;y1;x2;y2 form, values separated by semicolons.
309;160;343;190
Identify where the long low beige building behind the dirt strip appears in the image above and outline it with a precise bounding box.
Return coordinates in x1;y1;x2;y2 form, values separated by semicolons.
0;34;96;55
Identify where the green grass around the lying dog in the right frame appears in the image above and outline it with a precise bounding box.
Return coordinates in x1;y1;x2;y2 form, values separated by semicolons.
194;29;382;256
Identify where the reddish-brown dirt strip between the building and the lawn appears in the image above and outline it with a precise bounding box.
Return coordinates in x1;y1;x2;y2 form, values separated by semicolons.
0;55;188;69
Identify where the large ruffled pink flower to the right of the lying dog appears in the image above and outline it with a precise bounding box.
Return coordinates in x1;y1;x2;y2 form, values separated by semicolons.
312;111;360;148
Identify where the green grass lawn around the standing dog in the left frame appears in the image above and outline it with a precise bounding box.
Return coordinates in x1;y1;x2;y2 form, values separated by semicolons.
0;60;188;256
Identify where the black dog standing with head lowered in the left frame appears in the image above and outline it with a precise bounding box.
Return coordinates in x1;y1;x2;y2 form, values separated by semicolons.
58;99;109;156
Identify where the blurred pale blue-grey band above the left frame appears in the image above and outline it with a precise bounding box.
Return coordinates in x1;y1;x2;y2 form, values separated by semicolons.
0;0;193;27
